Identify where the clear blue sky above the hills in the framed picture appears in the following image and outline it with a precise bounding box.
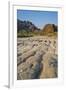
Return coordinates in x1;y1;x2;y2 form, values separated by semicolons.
17;10;58;28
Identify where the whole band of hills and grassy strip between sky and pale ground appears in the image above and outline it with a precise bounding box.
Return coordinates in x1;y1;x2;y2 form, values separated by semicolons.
17;20;58;37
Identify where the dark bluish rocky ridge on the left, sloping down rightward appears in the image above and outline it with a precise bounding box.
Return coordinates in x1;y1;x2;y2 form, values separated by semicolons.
17;19;39;32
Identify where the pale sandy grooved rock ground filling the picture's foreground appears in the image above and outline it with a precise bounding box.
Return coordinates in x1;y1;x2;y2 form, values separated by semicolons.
17;36;58;80
